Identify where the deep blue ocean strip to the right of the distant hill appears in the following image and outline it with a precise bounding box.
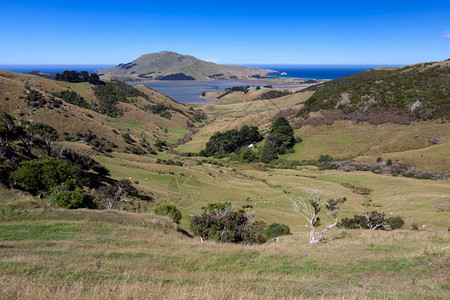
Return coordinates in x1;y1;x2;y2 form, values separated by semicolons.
247;64;403;79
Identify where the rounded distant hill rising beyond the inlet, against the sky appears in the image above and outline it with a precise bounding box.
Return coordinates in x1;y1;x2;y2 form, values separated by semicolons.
97;51;276;81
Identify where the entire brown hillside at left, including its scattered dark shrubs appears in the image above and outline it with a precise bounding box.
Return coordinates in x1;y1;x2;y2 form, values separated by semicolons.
0;71;204;153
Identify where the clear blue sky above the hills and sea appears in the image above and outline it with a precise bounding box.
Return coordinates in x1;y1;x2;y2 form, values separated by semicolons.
0;0;450;64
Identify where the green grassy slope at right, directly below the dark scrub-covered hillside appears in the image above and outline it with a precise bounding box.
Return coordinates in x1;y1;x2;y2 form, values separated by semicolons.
283;121;450;172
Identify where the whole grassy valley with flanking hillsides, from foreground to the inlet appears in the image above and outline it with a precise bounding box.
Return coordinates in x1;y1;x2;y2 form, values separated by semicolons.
0;58;450;299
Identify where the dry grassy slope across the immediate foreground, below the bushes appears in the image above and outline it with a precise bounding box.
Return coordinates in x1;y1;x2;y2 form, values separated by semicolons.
0;210;450;299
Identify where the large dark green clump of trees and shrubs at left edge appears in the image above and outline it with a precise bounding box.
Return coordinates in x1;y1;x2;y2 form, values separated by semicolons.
0;112;144;208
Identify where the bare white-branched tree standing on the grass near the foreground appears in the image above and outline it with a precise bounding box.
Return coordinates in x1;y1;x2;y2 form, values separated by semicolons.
291;189;347;245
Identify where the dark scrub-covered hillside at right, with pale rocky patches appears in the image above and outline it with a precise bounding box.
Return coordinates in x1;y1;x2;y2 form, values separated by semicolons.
299;60;450;119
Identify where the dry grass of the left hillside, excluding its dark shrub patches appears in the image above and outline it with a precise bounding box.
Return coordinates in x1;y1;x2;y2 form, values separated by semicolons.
0;71;197;149
